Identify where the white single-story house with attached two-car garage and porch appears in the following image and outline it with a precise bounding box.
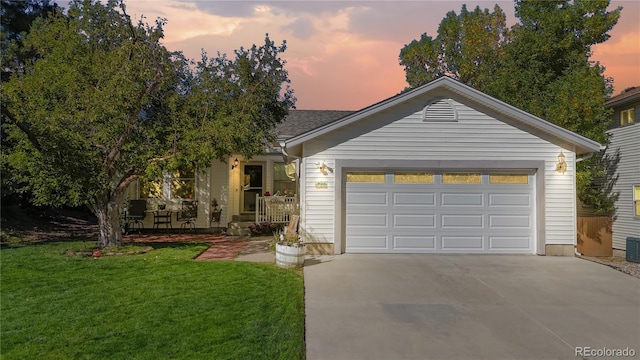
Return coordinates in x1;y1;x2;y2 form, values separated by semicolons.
124;77;601;255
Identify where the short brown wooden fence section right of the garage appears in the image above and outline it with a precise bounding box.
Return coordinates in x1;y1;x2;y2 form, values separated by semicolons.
577;216;613;256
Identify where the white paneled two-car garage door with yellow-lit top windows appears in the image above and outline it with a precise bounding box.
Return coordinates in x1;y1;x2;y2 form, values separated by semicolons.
345;171;535;253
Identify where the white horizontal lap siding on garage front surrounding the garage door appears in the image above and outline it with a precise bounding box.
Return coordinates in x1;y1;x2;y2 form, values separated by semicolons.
301;102;575;244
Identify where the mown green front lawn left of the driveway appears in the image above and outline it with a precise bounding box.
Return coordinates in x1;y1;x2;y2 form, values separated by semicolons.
0;243;305;360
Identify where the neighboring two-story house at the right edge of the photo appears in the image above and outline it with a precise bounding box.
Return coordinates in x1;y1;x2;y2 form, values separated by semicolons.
606;86;640;255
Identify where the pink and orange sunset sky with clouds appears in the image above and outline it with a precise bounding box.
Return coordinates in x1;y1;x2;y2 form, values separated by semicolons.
112;0;640;110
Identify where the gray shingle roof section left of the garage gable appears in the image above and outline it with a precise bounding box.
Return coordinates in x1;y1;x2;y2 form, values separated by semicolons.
276;110;355;139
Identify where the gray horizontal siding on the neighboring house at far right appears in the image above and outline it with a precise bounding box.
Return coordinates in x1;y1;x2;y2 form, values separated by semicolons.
607;124;640;250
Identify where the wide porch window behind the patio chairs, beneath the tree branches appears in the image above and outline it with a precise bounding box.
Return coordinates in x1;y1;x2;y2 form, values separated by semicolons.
138;169;196;199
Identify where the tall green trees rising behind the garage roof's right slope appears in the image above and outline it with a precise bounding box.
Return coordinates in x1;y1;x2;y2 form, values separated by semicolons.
400;0;621;213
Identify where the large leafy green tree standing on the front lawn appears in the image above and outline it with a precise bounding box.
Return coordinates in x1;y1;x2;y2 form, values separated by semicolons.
2;0;295;247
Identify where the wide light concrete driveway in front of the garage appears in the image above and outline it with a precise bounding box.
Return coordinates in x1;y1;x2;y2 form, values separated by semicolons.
304;254;640;360
